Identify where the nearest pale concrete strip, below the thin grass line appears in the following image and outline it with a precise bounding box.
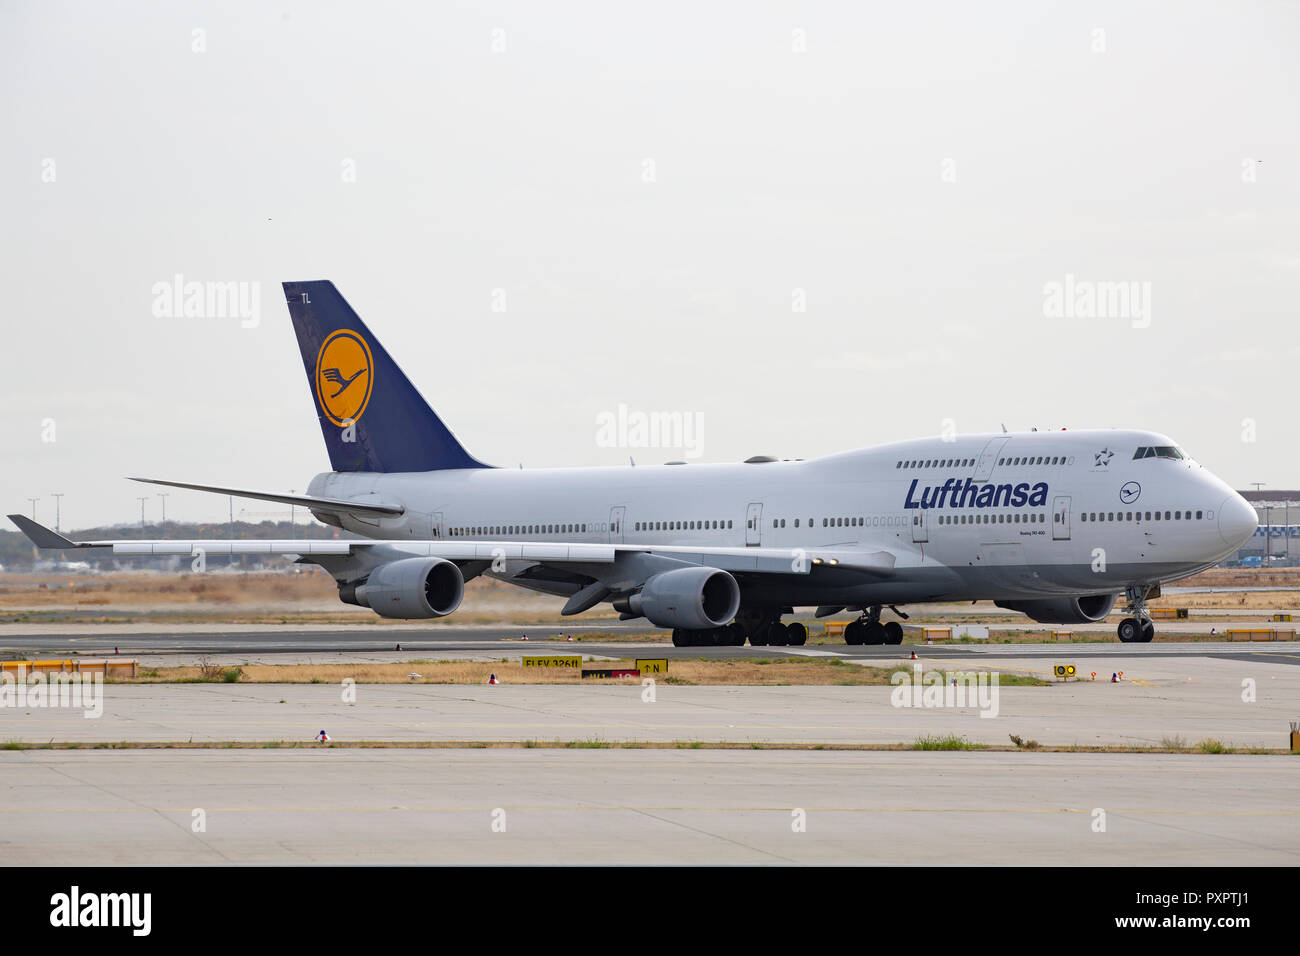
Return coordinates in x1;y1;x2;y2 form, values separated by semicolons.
0;750;1300;866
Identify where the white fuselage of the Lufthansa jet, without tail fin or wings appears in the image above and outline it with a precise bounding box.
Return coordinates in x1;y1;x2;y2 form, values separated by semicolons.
299;431;1256;605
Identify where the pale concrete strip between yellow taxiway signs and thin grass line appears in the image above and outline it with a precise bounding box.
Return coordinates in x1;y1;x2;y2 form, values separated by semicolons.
0;658;1300;749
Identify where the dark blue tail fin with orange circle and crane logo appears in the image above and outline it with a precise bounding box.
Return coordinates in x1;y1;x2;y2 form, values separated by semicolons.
283;281;489;472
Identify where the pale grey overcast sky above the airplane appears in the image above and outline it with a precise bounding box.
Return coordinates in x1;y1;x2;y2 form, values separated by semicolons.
0;0;1300;528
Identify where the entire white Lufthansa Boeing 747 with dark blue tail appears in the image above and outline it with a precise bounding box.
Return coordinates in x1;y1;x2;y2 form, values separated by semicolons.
10;281;1257;646
